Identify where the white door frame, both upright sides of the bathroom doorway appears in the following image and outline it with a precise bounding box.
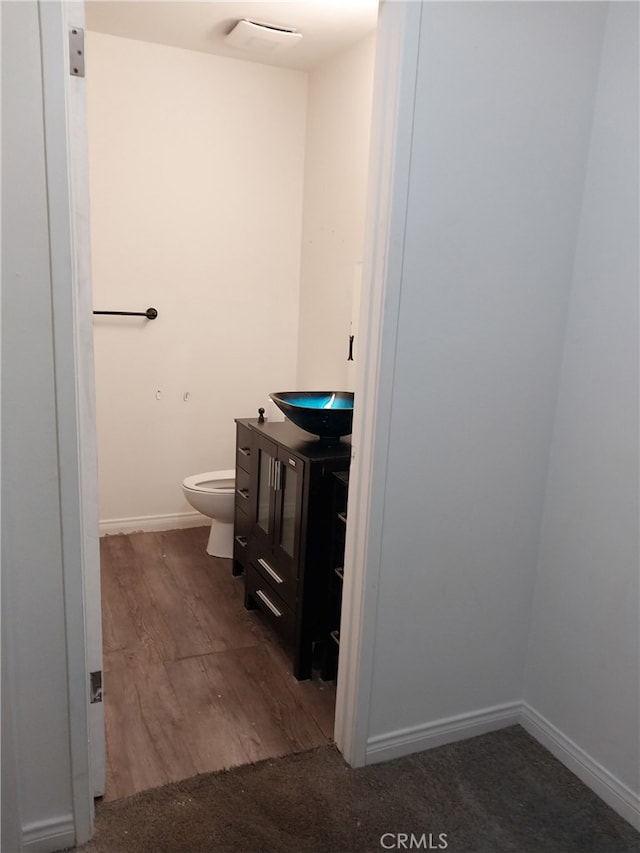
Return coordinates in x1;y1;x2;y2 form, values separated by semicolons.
47;0;422;844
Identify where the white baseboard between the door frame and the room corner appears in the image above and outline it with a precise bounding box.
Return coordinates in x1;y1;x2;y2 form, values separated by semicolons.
365;702;521;764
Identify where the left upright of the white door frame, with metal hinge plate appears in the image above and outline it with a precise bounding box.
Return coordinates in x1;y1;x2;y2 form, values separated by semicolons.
38;0;105;844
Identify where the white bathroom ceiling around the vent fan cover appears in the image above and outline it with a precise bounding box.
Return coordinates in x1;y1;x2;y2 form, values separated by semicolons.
85;0;378;71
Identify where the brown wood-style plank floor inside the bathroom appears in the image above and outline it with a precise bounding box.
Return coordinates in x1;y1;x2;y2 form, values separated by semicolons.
100;527;335;800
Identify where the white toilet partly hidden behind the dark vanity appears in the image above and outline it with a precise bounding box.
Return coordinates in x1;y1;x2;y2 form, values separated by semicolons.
182;468;236;557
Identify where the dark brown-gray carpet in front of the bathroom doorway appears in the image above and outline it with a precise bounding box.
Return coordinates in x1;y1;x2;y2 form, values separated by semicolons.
74;726;640;853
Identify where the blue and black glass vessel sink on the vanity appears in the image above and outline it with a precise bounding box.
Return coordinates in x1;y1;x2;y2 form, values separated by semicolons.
269;391;353;443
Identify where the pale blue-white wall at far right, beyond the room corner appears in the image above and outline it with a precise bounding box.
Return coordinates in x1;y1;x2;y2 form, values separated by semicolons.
524;3;640;808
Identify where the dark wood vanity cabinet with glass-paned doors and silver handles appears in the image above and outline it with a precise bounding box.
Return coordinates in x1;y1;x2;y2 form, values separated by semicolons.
234;419;351;679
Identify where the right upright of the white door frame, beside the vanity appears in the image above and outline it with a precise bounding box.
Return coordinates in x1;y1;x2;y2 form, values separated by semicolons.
334;0;422;767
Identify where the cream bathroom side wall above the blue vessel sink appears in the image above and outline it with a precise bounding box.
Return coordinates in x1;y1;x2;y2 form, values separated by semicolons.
297;34;375;389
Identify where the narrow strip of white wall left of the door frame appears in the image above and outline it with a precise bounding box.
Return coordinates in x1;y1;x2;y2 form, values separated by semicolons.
2;2;74;853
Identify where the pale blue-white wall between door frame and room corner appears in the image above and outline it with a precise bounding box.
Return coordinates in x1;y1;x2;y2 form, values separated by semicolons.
369;3;604;740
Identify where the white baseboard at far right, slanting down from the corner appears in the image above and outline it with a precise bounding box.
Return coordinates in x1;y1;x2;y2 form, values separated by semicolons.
520;702;640;830
